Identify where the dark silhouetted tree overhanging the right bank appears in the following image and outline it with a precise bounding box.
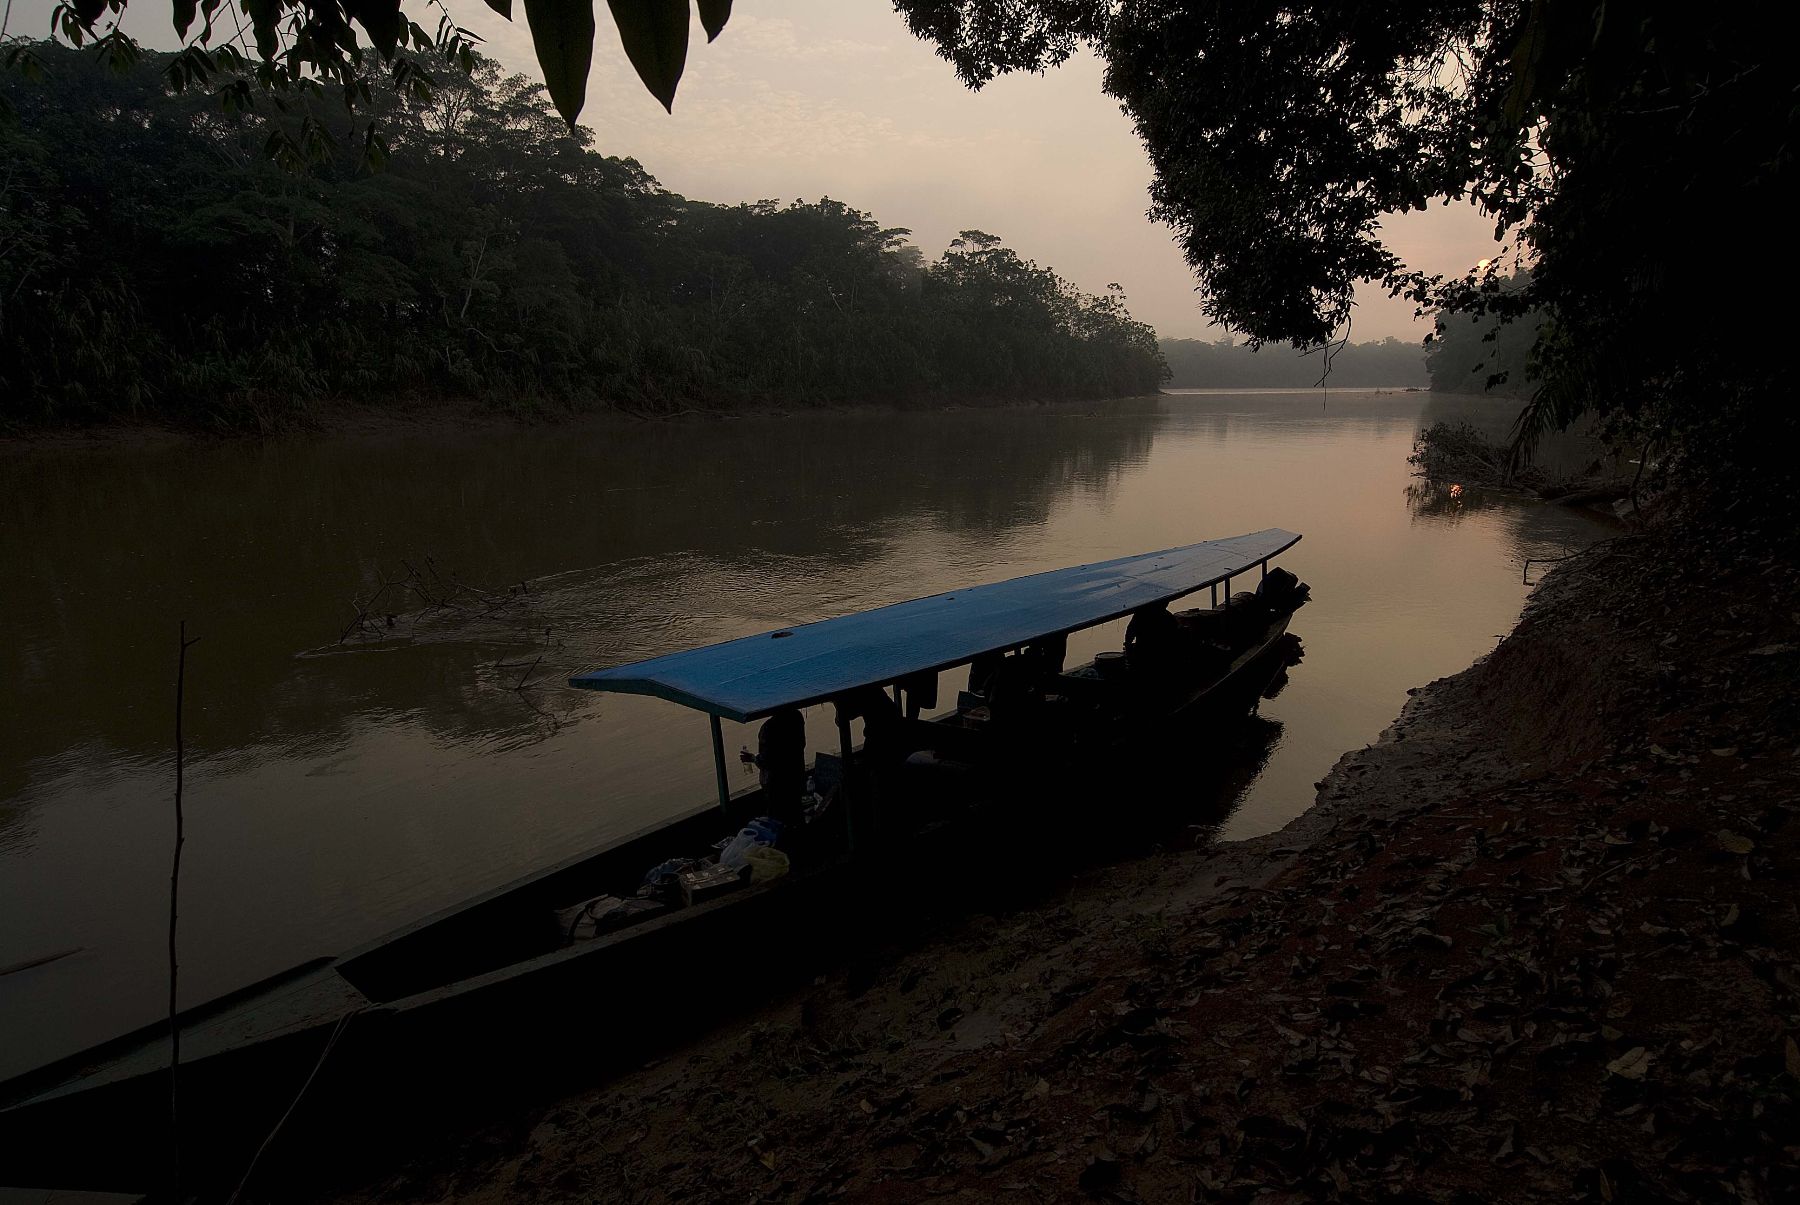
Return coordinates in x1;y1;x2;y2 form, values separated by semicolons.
895;0;1800;493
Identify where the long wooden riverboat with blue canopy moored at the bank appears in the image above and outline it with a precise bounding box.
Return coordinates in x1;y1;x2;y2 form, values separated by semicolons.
0;528;1307;1196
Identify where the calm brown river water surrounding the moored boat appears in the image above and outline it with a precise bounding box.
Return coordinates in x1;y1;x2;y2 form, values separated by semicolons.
0;391;1606;1075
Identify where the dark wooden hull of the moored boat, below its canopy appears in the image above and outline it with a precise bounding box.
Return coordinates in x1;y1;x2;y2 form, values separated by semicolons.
0;614;1289;1196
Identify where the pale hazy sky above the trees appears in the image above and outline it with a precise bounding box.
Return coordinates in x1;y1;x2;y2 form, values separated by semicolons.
13;0;1492;340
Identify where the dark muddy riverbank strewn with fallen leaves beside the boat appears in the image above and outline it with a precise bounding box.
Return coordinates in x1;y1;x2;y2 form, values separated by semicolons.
291;511;1800;1201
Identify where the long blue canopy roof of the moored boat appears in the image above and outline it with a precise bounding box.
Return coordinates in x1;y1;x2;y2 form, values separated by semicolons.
569;528;1300;722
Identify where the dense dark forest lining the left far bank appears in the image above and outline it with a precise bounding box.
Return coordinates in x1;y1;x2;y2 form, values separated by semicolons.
0;45;1165;427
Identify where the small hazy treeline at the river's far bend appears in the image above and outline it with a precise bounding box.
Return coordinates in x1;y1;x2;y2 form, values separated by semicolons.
1161;337;1427;389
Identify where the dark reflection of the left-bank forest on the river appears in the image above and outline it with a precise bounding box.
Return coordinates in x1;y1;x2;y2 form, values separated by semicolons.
0;405;1161;825
